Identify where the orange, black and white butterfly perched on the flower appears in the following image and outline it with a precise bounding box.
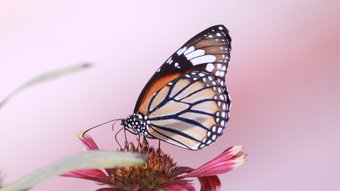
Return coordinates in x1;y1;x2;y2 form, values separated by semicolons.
121;25;231;150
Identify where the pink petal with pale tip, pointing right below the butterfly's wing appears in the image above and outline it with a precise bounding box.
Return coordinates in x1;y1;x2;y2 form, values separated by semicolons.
184;146;246;177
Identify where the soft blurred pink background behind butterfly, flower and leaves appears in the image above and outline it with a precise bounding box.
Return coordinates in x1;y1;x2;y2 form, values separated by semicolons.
0;0;340;191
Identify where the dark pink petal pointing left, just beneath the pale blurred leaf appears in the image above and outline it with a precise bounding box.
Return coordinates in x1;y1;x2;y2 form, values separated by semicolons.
61;169;110;184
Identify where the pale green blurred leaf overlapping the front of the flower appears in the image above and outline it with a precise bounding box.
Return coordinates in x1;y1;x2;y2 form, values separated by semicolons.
0;150;145;191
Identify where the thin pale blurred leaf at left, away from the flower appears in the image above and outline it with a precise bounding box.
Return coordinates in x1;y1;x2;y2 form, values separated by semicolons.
0;64;90;108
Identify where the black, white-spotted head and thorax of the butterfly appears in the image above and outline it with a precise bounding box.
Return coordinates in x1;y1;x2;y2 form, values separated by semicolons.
122;113;149;136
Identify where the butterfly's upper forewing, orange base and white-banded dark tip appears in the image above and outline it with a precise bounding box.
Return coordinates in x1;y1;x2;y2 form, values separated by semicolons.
134;25;231;115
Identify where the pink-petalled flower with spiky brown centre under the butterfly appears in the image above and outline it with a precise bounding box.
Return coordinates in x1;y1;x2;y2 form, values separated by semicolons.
63;135;246;191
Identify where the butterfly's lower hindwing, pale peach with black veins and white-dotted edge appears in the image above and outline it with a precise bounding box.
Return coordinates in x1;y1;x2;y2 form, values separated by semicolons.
147;71;230;150
